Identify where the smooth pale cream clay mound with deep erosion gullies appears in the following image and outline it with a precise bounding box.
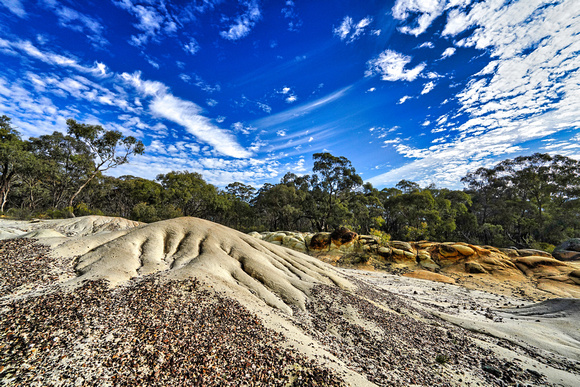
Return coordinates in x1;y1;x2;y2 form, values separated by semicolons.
75;218;350;313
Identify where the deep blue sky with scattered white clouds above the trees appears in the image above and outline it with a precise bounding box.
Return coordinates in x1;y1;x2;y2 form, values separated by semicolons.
0;0;580;188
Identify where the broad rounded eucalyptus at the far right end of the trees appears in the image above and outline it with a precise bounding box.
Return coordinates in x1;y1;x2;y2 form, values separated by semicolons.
462;153;580;246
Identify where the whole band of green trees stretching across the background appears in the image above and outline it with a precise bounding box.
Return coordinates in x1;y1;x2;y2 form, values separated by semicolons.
0;116;580;250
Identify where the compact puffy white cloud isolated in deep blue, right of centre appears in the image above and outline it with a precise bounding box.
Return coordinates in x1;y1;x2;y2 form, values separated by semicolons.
365;50;425;81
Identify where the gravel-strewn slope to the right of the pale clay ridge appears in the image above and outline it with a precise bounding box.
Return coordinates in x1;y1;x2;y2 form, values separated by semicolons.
294;280;546;386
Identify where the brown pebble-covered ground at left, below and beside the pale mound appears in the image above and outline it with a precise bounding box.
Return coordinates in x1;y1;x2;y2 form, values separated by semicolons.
0;240;344;386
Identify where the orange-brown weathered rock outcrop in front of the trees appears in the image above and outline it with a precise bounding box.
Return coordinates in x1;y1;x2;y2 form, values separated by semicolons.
252;228;580;297
